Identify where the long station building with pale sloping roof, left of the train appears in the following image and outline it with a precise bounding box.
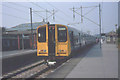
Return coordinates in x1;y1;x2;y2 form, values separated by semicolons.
2;21;48;51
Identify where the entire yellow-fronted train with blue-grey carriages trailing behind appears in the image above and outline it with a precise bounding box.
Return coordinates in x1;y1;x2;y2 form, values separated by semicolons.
37;24;96;65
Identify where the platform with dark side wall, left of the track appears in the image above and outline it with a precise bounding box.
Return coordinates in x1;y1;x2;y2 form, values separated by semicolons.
0;49;42;75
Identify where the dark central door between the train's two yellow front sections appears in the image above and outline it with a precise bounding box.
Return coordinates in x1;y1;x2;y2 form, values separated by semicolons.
48;25;55;56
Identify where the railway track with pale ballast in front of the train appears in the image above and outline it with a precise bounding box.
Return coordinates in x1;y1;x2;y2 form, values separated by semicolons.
2;57;66;80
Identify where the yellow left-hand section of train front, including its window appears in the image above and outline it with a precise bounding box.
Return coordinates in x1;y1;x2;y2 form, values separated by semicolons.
37;25;48;56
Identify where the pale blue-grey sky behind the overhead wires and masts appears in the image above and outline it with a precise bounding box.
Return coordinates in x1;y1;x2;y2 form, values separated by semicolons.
0;2;118;34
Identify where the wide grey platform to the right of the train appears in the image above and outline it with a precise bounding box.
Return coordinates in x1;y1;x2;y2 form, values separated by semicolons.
46;43;118;78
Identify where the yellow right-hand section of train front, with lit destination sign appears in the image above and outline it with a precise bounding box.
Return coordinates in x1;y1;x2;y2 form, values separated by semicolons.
56;25;71;58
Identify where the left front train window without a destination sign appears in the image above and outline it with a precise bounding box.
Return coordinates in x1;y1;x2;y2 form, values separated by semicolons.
38;27;46;42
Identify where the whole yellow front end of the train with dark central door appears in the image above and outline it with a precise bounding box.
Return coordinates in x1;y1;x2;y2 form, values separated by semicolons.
37;24;71;64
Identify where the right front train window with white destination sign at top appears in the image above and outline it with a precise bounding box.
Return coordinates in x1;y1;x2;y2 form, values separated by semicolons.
58;27;67;42
